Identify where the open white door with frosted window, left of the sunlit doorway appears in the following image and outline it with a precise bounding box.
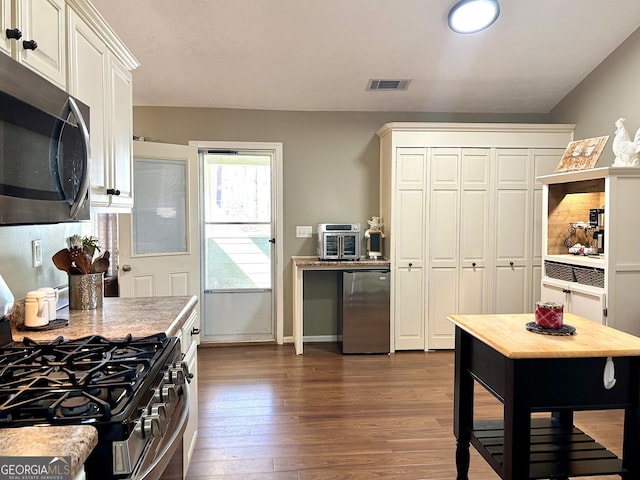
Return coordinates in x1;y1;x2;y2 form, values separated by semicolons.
118;142;200;297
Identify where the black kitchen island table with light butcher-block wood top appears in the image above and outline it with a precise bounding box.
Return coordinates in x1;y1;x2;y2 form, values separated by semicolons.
449;313;640;480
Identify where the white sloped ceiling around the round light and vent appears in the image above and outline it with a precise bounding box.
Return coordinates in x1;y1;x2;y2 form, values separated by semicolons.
86;0;640;113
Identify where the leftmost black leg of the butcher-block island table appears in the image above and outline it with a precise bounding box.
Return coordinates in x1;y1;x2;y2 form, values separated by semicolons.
453;327;473;480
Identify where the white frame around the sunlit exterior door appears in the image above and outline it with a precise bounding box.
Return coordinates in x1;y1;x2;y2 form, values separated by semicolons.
189;140;284;345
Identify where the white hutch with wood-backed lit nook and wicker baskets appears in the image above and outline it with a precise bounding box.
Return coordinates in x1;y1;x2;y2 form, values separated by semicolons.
538;167;640;335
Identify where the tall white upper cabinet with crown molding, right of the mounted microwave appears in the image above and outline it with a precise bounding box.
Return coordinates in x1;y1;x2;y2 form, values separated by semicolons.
67;0;137;212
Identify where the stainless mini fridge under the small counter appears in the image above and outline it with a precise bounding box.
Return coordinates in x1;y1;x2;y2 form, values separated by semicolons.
338;270;391;353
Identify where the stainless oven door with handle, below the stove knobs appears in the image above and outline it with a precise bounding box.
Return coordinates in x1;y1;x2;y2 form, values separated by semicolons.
127;385;189;480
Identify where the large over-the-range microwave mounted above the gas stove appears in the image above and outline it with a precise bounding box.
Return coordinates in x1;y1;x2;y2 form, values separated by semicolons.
0;54;90;225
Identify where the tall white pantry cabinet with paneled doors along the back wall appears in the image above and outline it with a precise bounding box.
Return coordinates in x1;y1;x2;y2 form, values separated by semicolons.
378;123;573;351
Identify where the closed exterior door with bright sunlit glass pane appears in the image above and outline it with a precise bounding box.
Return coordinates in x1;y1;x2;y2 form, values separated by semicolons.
200;150;275;342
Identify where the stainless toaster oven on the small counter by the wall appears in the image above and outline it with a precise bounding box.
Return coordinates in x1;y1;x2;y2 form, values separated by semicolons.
318;223;362;260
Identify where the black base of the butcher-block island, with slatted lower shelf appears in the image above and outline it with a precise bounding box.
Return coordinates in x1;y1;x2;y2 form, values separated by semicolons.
454;327;640;480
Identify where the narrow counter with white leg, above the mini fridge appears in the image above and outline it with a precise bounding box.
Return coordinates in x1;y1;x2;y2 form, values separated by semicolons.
291;256;390;355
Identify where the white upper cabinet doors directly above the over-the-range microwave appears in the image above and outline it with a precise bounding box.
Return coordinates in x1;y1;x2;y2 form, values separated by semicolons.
0;0;67;89
